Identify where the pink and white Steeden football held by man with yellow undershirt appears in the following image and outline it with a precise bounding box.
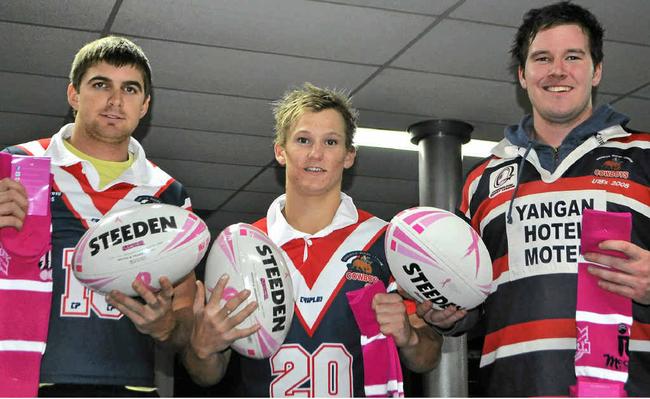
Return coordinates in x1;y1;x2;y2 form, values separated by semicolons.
72;204;210;296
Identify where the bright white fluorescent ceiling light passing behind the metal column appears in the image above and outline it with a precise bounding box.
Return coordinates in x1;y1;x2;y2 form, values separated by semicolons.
354;127;497;158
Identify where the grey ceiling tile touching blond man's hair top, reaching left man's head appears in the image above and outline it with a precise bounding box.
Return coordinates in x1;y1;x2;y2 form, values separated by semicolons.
136;39;376;100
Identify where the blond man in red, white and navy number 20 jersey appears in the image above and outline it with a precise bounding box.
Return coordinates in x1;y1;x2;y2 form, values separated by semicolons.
184;84;441;396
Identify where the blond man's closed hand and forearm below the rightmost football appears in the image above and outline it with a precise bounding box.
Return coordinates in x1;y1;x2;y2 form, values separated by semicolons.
372;293;442;373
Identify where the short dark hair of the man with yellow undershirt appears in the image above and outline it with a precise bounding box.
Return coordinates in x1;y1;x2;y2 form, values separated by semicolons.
70;36;151;98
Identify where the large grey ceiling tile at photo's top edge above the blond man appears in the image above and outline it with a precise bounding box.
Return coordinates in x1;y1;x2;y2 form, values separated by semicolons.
113;0;433;64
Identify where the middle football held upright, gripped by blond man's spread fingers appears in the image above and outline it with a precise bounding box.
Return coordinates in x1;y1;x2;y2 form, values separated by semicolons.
205;223;295;359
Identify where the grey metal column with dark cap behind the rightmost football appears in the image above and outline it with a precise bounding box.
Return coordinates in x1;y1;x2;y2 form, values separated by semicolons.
407;119;474;397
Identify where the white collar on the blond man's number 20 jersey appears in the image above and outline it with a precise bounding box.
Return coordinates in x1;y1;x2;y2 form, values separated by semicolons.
266;192;359;246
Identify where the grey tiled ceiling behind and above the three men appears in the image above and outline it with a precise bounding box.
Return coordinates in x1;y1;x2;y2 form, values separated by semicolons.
0;0;650;233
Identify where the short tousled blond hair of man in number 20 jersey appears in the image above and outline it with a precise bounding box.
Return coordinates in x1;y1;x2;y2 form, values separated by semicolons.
273;82;358;150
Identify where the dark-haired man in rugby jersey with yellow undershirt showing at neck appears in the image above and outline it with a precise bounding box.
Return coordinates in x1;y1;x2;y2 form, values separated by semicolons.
0;37;195;396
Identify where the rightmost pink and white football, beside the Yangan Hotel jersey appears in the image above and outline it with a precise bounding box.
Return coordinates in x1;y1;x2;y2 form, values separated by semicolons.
385;207;492;309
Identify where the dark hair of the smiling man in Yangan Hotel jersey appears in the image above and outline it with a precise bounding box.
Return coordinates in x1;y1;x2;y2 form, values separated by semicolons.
510;1;605;69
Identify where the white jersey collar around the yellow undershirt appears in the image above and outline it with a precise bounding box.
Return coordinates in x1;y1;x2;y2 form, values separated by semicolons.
44;123;152;191
